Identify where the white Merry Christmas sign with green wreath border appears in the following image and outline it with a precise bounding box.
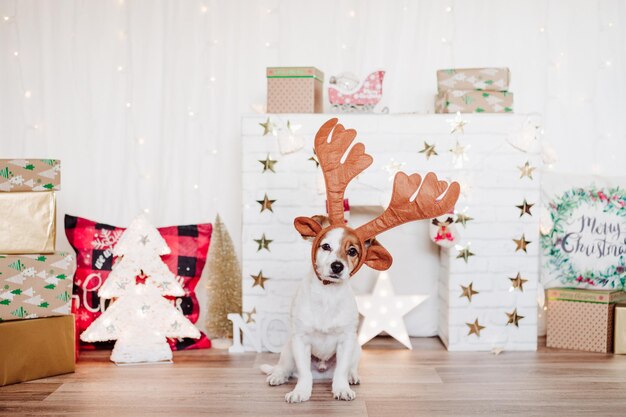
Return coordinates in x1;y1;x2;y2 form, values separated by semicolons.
541;187;626;289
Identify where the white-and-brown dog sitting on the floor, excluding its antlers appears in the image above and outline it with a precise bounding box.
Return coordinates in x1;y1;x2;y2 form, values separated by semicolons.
261;216;391;403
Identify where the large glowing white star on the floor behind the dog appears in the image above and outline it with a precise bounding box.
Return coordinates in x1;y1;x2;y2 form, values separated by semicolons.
356;272;428;349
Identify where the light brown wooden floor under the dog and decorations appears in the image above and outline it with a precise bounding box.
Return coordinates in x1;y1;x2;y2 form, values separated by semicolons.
0;338;626;417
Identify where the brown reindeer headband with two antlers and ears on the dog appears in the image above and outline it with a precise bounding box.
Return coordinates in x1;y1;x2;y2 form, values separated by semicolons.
294;118;460;275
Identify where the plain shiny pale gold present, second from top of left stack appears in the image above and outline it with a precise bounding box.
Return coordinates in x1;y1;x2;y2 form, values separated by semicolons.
0;191;56;254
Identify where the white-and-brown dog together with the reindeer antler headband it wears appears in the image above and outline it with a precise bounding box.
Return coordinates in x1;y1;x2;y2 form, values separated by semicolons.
261;119;460;402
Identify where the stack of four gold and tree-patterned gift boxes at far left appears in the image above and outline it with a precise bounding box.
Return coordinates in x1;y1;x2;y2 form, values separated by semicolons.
0;159;76;386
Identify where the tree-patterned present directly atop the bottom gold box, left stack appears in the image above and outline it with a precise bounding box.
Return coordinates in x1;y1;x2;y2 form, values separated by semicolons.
0;252;76;321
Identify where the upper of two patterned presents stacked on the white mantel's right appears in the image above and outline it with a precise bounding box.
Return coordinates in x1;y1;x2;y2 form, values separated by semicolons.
437;68;510;93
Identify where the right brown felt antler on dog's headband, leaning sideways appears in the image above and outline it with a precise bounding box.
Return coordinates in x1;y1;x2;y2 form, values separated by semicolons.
355;172;461;241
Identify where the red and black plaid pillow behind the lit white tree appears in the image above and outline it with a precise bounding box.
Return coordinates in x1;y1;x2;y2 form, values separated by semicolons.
65;215;212;350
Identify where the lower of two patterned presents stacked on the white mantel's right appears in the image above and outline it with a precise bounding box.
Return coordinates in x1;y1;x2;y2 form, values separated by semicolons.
435;90;513;113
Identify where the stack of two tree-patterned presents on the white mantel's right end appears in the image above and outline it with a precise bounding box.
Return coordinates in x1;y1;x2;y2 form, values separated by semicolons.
435;68;513;113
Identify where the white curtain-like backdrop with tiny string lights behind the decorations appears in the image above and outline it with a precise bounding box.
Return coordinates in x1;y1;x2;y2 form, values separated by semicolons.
0;0;626;258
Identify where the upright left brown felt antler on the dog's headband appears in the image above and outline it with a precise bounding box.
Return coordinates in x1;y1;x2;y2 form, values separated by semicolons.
315;118;373;226
